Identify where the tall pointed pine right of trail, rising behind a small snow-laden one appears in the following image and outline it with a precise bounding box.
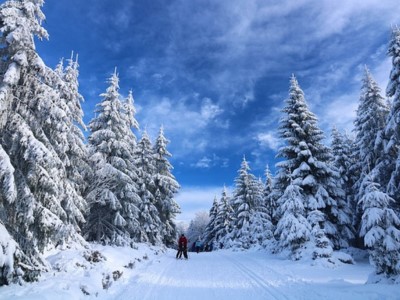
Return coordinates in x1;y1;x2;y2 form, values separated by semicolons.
274;75;344;248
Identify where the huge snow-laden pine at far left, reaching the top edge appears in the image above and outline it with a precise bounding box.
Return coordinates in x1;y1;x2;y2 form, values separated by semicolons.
0;0;84;282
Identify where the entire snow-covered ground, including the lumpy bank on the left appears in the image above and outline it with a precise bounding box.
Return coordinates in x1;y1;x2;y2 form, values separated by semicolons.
0;244;400;300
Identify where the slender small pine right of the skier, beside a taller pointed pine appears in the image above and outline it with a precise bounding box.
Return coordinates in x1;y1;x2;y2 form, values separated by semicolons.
215;186;234;248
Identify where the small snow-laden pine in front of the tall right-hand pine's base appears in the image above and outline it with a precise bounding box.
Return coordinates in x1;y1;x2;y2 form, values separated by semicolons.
274;183;312;260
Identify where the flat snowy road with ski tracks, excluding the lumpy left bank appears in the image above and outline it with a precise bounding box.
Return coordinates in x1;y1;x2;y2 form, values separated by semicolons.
102;251;400;300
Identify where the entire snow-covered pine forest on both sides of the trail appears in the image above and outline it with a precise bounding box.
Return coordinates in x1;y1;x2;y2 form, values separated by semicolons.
0;0;400;285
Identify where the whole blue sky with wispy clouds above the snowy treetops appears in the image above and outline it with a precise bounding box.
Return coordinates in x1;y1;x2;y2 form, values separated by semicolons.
33;0;400;221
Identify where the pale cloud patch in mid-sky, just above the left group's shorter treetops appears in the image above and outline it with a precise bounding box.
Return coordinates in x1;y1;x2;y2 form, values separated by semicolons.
135;95;229;158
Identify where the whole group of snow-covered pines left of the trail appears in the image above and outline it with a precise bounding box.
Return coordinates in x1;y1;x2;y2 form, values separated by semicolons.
0;0;180;286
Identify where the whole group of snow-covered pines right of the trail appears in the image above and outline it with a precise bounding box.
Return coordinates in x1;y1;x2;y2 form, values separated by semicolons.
203;31;400;281
